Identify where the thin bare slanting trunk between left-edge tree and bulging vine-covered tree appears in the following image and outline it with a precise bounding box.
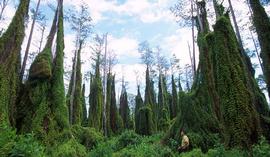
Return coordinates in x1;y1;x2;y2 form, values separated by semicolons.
20;0;40;82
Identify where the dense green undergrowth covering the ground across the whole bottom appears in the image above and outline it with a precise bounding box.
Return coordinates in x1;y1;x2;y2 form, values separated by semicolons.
0;122;270;157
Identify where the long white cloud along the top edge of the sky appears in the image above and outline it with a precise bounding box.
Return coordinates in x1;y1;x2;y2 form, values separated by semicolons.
65;0;176;23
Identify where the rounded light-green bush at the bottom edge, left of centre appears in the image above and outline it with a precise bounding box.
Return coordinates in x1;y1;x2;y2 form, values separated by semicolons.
51;139;87;157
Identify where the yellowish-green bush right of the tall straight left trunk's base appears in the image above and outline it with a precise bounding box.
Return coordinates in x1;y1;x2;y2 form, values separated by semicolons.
71;125;103;150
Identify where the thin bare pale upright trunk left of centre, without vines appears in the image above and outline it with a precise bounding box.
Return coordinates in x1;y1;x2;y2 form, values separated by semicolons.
103;33;108;136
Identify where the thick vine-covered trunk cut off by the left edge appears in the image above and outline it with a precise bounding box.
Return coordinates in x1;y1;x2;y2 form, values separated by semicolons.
0;0;30;125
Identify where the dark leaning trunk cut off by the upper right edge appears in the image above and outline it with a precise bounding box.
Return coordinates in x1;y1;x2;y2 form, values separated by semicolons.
249;0;270;98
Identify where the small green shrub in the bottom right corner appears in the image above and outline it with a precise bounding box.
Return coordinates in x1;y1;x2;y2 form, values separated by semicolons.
252;137;270;157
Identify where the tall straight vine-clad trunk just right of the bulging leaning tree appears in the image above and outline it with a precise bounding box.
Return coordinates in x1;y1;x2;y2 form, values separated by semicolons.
51;0;69;131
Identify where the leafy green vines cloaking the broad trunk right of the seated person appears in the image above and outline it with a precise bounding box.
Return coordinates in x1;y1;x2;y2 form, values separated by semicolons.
212;16;259;147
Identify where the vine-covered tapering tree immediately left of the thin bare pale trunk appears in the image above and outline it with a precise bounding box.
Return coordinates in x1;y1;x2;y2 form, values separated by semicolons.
88;54;102;130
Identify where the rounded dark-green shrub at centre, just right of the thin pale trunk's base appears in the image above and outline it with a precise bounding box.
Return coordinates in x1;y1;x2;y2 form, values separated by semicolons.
117;131;142;150
